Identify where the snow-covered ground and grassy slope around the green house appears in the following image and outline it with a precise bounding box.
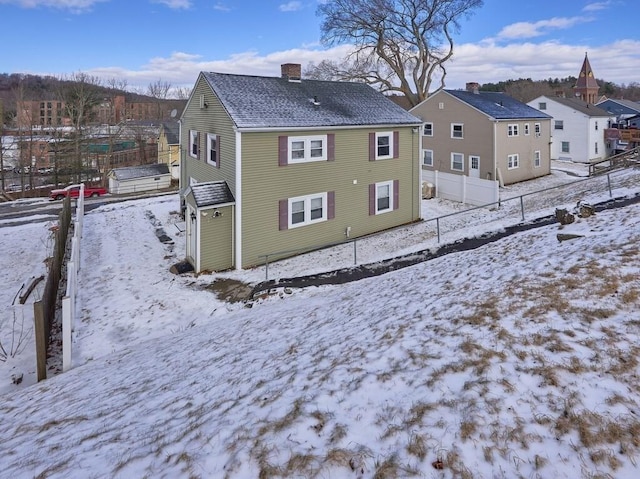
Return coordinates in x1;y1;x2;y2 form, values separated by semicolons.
0;163;640;478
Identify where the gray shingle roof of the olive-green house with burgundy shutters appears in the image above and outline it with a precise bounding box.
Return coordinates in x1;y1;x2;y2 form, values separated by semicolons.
203;72;422;128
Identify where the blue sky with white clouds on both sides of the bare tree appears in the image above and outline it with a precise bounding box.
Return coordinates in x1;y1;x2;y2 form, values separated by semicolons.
0;0;640;94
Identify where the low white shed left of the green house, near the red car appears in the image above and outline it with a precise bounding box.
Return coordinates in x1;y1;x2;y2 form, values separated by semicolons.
107;163;171;195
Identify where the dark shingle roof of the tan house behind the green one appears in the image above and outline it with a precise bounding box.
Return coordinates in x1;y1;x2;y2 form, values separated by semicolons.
445;90;551;120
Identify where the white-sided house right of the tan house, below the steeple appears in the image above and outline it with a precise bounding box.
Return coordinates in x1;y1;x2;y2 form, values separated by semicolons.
528;96;615;163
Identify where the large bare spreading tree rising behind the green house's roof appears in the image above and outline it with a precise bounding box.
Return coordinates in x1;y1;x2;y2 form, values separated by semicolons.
316;0;483;105
